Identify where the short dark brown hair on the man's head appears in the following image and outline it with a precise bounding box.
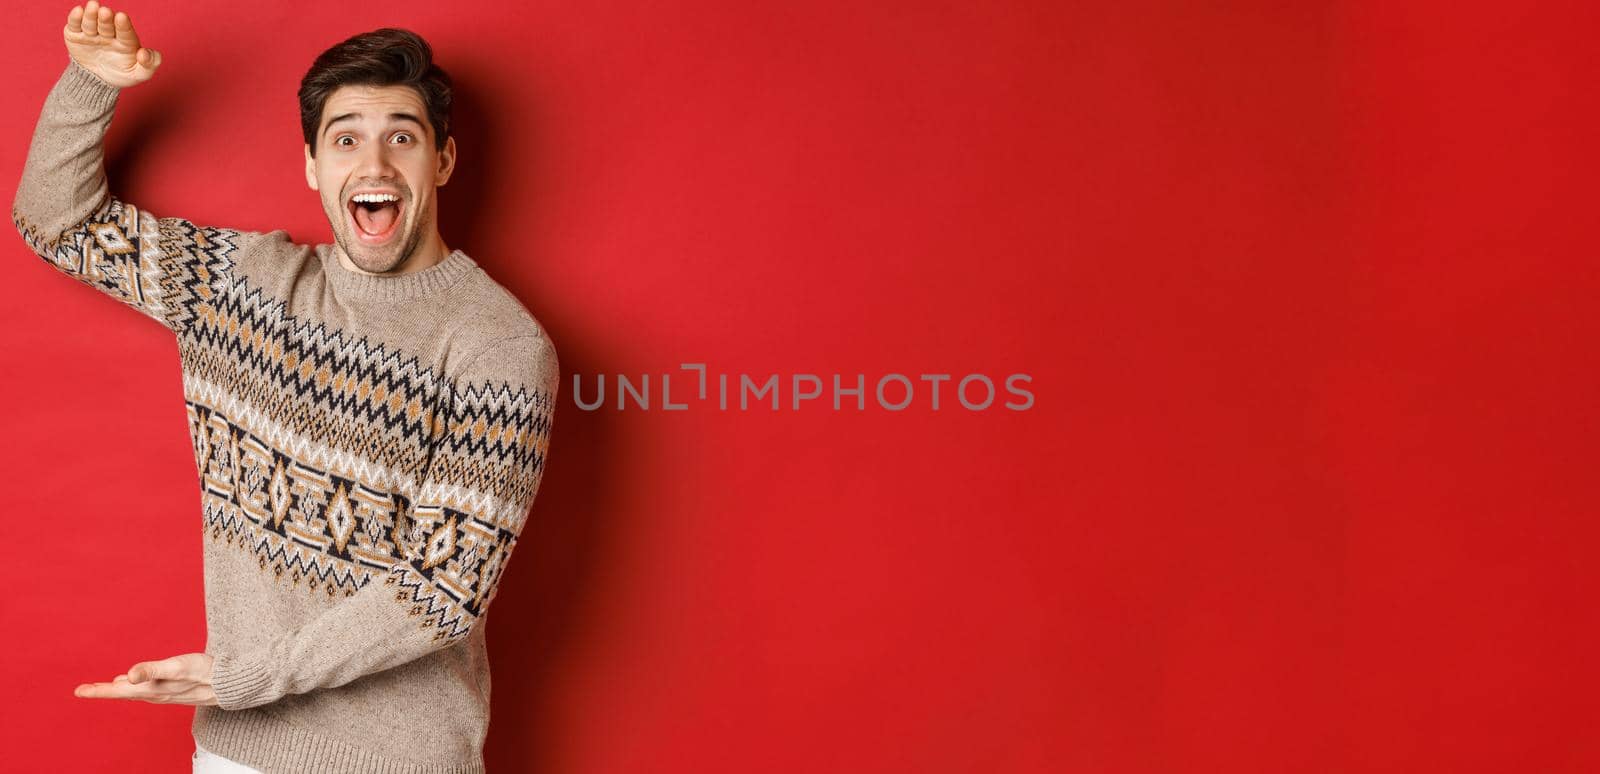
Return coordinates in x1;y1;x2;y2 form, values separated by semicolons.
299;27;451;157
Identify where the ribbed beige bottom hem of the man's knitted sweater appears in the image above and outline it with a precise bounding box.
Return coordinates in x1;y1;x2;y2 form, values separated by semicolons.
192;705;483;774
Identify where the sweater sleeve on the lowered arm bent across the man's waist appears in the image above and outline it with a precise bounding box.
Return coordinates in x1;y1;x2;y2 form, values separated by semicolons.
211;331;560;710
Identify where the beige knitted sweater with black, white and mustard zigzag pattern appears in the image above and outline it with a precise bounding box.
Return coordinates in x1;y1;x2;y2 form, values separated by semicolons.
13;61;558;774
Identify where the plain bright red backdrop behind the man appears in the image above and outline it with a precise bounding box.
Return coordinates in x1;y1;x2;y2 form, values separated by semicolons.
0;0;1600;772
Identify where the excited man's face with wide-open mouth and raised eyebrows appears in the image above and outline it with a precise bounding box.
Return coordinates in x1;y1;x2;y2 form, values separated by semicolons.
306;86;456;273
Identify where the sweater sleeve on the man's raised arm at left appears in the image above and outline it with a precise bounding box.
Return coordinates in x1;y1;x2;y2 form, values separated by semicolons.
11;58;261;333
